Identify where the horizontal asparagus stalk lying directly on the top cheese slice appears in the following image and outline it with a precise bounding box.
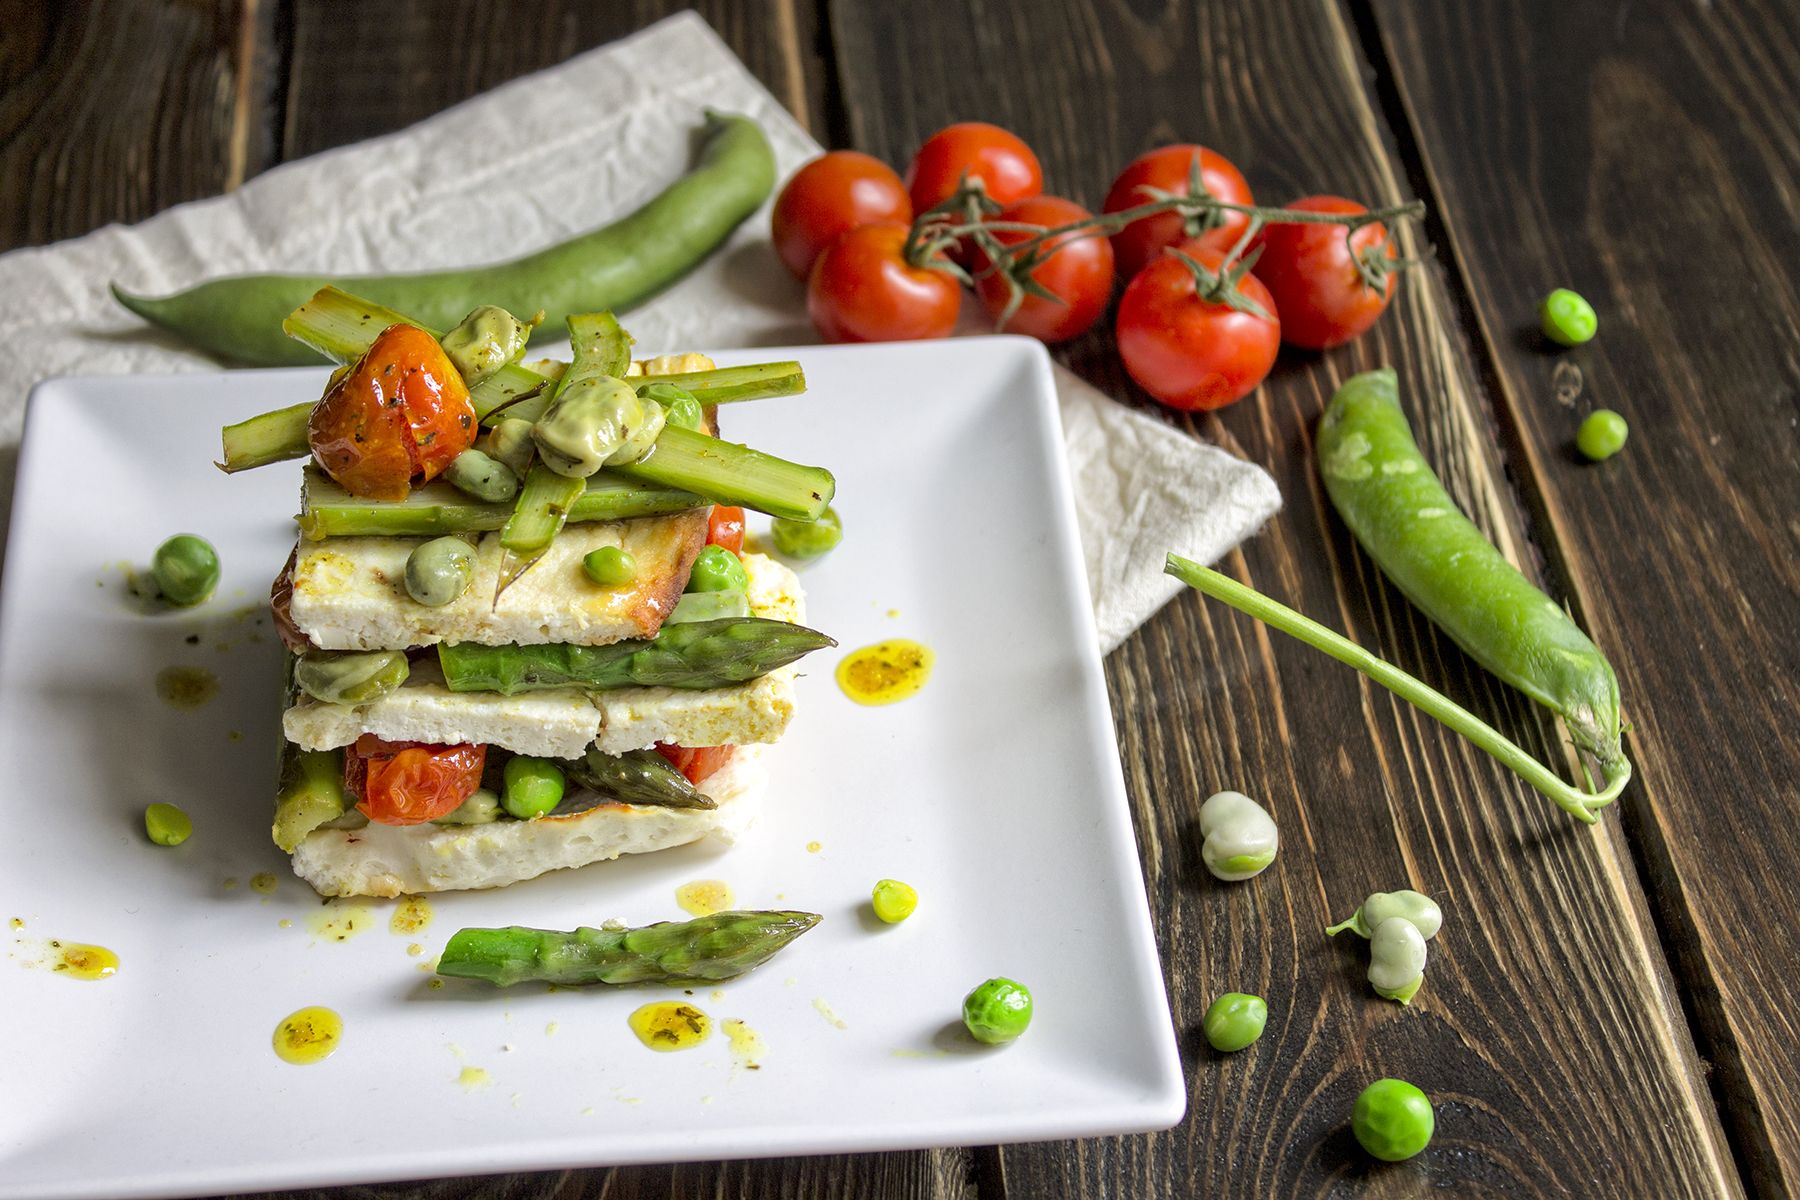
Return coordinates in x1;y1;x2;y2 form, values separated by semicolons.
297;464;707;542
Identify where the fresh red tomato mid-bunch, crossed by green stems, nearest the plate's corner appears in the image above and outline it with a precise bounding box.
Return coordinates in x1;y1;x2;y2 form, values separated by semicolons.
976;196;1112;342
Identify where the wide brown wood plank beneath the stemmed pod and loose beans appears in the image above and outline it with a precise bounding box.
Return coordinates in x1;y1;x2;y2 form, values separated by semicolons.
832;0;1737;1196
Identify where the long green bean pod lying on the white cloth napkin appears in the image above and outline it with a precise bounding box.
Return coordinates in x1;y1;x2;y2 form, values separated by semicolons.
113;112;776;367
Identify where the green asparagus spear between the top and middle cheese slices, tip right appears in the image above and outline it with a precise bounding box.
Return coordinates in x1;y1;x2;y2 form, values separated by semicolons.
437;617;837;696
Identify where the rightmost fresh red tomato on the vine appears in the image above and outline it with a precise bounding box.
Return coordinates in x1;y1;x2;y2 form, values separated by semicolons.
1251;196;1400;351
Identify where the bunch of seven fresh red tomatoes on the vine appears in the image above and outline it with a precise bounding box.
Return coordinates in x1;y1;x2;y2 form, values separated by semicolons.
774;122;1399;408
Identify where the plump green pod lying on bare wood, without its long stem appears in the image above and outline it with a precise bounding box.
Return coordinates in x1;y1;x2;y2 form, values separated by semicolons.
1318;369;1624;779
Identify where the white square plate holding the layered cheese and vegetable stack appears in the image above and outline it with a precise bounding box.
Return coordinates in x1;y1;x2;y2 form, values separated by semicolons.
0;338;1184;1196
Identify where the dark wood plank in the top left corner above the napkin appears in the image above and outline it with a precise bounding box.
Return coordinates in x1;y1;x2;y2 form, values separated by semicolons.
0;0;274;250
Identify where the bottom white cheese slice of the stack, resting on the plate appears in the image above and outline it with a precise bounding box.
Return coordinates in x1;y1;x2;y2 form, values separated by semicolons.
293;747;769;896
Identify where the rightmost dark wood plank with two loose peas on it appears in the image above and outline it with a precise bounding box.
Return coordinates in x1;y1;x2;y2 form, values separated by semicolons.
1377;0;1800;1195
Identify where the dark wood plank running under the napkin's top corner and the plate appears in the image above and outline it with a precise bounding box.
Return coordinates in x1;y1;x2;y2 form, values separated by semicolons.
262;0;972;1200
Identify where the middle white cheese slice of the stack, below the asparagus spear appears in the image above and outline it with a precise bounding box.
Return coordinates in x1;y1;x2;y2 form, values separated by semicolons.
281;550;806;759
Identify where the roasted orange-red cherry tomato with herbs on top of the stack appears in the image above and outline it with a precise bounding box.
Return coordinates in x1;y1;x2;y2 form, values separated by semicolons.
306;326;481;500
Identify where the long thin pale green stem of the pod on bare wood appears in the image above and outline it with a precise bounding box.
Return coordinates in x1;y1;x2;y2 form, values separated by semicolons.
1165;554;1631;824
